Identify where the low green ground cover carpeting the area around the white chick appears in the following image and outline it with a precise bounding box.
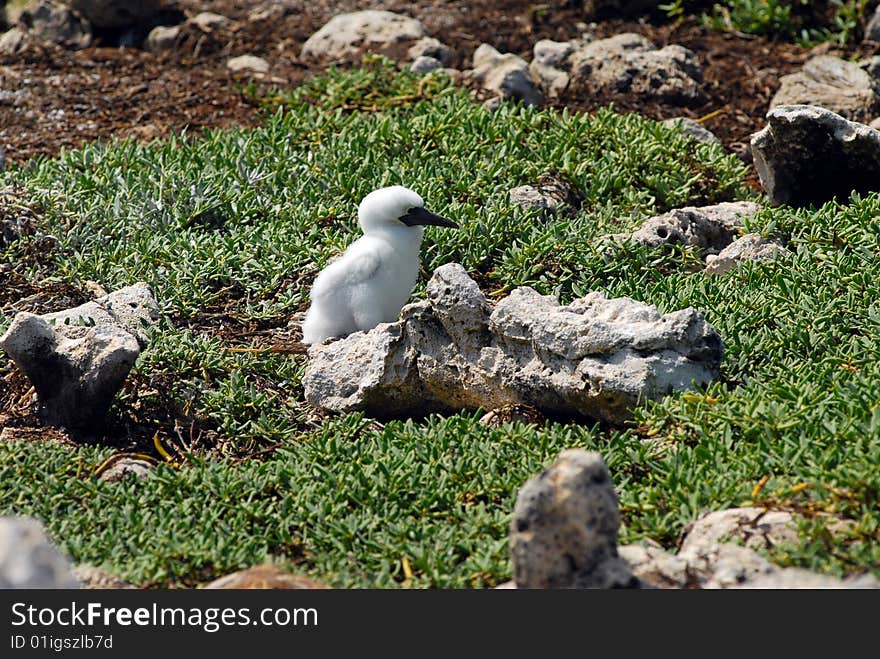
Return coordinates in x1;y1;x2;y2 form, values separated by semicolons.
0;58;880;588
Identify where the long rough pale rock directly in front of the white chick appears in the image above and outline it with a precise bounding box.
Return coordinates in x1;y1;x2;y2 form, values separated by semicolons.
303;263;723;423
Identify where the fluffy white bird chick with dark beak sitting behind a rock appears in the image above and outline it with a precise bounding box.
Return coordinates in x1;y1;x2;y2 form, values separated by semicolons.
302;185;458;344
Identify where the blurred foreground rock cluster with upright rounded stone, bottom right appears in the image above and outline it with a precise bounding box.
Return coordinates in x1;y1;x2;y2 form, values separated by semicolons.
499;456;880;589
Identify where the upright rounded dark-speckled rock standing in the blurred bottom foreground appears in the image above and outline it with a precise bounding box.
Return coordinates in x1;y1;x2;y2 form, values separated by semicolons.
510;449;640;588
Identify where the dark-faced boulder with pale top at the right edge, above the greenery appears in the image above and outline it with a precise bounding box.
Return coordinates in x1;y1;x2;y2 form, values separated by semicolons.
751;105;880;206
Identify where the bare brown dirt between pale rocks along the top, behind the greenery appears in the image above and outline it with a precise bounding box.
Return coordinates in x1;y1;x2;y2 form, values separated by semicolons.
0;0;872;164
